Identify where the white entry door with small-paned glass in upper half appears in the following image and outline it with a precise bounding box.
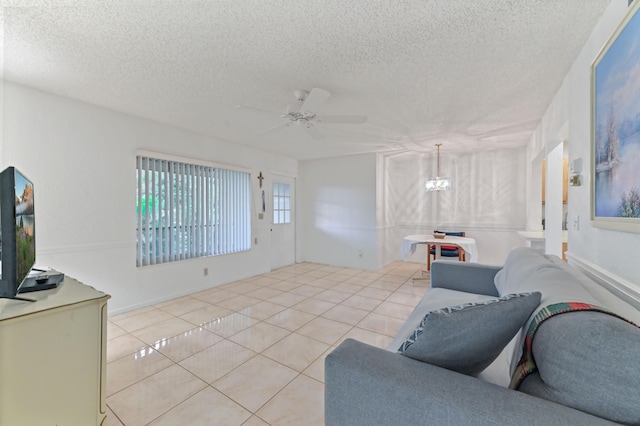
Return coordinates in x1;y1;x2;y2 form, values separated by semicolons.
271;175;296;270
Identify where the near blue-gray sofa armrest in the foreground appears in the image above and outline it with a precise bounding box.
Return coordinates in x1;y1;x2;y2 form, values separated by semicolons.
324;339;614;426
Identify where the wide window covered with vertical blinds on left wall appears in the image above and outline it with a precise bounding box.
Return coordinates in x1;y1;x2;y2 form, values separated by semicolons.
136;156;251;266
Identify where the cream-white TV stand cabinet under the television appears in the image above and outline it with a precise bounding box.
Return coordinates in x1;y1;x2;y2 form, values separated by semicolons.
0;276;110;425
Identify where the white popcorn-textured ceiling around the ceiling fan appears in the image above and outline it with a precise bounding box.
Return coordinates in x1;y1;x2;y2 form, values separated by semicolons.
0;0;626;159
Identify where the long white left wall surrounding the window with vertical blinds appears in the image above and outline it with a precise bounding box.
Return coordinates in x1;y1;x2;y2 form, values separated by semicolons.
1;82;298;313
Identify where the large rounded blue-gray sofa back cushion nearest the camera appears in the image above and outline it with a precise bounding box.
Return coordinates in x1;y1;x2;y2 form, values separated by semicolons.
519;311;640;425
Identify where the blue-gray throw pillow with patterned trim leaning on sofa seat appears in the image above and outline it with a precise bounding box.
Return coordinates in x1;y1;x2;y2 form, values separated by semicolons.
398;292;541;375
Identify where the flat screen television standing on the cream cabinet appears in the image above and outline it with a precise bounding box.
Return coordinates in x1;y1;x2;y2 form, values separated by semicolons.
0;167;36;298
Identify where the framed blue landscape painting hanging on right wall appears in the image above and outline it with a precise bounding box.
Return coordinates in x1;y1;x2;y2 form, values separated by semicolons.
591;1;640;232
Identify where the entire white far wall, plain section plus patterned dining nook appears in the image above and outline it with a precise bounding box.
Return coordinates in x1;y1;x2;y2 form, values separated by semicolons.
300;148;526;270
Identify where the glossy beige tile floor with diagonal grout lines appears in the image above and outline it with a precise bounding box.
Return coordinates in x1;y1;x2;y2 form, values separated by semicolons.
107;262;429;426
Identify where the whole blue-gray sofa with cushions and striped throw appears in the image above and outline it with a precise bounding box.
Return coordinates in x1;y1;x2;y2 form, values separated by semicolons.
325;248;640;426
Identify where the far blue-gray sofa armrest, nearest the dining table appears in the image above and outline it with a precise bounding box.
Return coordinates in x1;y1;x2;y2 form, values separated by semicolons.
431;260;502;296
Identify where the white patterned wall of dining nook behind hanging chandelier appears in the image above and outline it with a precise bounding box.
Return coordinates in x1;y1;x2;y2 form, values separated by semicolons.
380;148;526;265
